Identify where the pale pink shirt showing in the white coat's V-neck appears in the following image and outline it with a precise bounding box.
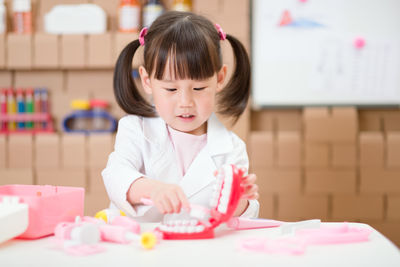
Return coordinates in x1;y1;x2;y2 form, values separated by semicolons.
168;126;207;176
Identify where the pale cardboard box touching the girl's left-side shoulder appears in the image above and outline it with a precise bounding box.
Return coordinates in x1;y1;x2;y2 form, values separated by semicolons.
88;134;114;169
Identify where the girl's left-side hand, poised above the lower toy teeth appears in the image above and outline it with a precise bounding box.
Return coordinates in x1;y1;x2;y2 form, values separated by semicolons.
150;182;190;214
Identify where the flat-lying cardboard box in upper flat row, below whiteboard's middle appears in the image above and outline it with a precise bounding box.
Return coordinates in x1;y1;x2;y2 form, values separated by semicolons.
305;168;356;194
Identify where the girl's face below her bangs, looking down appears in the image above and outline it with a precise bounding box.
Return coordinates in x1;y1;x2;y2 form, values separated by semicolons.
139;64;226;135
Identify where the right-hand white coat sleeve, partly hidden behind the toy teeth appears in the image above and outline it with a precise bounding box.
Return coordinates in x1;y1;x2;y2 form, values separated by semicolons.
229;133;260;218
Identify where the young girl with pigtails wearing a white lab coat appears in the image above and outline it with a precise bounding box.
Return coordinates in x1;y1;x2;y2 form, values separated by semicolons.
102;12;259;222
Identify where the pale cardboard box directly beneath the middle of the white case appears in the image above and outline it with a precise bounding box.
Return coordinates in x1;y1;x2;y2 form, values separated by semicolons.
60;34;87;68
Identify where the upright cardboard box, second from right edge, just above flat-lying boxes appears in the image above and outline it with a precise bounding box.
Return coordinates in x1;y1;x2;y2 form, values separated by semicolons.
359;132;384;168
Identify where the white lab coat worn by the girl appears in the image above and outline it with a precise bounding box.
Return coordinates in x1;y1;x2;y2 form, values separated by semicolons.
102;114;259;222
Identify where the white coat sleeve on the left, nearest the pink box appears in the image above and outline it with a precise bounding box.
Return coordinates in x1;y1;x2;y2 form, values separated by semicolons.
102;116;151;216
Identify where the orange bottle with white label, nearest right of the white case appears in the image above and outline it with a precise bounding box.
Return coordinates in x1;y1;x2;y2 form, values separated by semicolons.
118;0;140;32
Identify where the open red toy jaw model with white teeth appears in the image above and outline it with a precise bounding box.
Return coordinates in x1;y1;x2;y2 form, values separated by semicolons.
151;164;244;239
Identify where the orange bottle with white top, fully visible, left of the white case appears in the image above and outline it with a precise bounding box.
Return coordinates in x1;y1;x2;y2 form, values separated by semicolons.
13;0;32;33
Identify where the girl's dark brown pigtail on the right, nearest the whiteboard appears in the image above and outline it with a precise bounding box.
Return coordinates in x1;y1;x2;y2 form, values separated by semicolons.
219;34;251;122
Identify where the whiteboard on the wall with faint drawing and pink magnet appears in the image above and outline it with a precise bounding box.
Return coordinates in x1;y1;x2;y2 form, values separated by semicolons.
252;0;400;108
